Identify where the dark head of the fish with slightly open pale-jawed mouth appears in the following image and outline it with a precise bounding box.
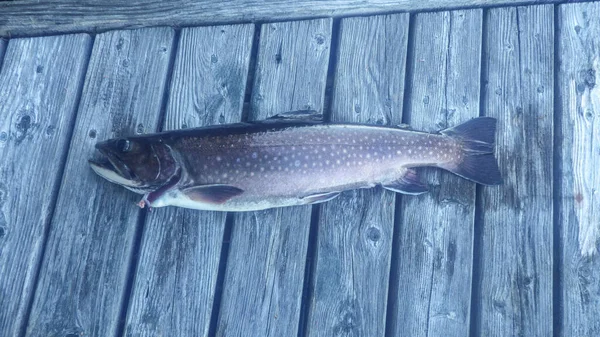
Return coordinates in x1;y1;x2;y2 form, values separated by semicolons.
89;137;178;194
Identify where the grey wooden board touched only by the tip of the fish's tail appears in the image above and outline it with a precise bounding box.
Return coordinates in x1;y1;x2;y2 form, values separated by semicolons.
476;6;554;336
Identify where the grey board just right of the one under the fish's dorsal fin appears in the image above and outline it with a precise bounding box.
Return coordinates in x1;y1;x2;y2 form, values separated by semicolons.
308;14;409;336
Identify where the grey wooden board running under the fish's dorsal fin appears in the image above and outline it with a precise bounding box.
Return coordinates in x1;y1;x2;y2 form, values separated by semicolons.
217;19;332;336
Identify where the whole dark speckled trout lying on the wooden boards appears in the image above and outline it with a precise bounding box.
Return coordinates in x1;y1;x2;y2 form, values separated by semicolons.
89;111;503;212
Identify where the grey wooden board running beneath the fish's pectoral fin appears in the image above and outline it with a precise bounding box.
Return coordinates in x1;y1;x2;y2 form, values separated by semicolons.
125;25;254;336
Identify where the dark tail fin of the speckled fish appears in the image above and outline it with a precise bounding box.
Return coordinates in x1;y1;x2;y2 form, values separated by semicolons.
439;117;502;185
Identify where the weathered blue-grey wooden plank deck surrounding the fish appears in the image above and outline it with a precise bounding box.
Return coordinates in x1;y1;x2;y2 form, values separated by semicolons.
0;0;600;337
